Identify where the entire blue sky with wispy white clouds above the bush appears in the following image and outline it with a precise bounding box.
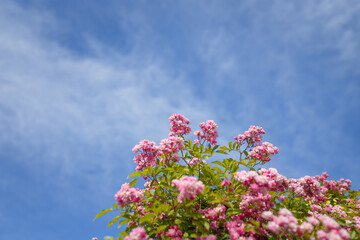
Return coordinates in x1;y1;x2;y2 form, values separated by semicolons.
0;0;360;240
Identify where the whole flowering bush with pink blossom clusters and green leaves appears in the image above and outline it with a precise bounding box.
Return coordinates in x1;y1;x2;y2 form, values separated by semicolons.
95;114;360;240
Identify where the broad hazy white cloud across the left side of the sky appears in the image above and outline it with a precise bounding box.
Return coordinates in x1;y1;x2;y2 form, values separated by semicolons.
0;2;208;208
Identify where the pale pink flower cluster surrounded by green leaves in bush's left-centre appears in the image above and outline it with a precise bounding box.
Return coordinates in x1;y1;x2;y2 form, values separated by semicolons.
172;176;205;203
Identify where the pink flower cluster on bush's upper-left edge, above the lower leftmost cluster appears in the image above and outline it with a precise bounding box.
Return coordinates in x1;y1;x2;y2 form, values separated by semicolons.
132;139;162;171
